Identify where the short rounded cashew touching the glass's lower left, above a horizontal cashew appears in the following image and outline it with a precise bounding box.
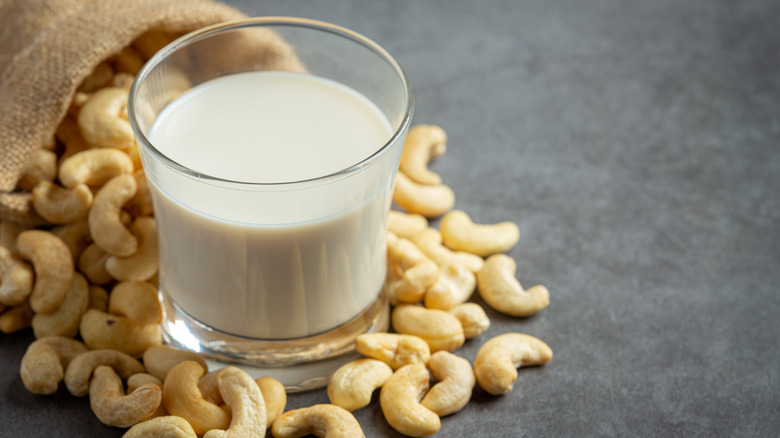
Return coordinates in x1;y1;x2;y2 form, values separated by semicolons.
108;281;165;326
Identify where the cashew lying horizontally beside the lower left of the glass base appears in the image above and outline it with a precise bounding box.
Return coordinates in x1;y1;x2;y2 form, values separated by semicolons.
79;309;162;357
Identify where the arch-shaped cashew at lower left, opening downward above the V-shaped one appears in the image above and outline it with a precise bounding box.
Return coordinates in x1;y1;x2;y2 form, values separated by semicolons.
65;349;144;397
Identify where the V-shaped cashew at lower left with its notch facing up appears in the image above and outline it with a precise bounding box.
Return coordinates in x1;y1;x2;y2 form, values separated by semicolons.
89;365;162;427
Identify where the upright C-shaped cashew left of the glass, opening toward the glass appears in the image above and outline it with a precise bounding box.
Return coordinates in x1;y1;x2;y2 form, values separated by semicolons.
87;175;138;257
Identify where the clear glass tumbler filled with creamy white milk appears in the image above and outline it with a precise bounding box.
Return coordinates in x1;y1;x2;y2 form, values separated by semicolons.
128;18;413;387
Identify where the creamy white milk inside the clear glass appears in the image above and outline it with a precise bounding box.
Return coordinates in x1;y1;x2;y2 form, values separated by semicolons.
148;72;392;339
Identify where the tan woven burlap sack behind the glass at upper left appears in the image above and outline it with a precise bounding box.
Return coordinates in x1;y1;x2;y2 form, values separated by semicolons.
0;0;296;224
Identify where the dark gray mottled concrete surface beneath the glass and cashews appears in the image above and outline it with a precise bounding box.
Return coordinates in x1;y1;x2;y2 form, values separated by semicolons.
0;0;780;437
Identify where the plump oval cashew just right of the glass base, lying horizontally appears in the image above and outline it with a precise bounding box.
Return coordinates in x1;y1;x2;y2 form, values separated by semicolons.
390;304;466;353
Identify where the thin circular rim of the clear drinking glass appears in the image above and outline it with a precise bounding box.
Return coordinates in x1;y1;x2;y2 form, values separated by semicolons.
127;16;414;189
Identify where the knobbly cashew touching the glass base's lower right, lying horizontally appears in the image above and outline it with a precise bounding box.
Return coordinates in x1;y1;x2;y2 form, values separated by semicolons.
355;333;431;370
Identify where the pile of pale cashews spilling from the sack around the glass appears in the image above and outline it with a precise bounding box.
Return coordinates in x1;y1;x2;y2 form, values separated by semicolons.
0;35;552;438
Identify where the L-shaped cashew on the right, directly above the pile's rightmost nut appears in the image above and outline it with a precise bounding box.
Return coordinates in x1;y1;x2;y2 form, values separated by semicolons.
477;254;550;316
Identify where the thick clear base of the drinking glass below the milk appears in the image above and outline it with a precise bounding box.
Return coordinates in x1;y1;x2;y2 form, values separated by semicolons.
160;290;390;392
